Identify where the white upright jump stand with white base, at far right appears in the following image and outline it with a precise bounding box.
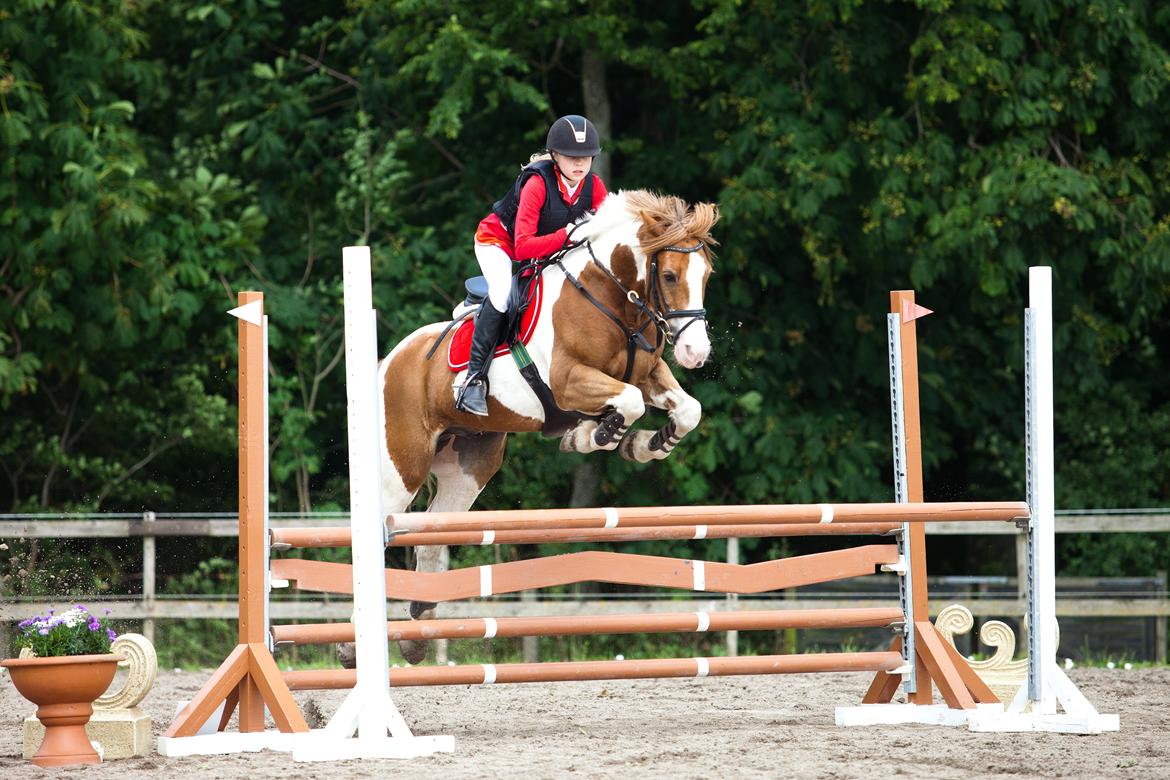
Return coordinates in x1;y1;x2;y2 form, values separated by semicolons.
970;265;1121;734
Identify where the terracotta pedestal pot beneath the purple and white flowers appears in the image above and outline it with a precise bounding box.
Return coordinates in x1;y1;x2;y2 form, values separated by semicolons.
0;653;119;766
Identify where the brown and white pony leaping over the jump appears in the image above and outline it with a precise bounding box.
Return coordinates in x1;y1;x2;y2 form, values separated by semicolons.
379;191;718;663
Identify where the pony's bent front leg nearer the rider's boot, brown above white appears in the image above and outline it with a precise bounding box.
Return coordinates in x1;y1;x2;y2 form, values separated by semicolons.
552;364;646;453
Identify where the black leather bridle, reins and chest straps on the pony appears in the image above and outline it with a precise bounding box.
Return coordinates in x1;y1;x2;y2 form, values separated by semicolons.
546;236;707;382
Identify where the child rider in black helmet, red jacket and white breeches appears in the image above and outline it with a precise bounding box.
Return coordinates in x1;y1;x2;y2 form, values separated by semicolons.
455;115;607;415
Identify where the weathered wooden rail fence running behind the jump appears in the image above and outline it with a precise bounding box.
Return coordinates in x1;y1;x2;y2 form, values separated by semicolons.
0;509;1170;663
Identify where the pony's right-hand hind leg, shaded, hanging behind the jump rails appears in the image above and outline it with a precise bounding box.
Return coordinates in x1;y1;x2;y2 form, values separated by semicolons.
398;433;508;663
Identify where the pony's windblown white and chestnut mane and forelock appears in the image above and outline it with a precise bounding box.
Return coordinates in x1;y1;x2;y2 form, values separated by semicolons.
586;189;720;254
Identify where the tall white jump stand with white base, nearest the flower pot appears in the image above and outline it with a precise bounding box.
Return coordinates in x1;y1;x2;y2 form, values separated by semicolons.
293;247;455;761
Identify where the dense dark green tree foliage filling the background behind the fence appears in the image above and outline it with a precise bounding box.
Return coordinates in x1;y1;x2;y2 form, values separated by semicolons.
0;0;1170;582
